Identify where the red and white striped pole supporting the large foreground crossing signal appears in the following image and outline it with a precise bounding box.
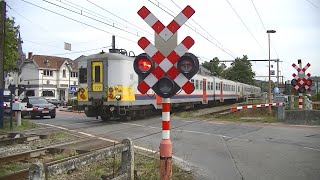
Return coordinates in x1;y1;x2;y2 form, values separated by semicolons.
160;98;172;180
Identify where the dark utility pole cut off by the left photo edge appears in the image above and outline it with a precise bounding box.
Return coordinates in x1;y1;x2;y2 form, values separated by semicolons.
0;0;6;128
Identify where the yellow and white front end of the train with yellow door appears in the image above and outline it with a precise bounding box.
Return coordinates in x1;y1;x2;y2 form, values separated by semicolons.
78;53;144;120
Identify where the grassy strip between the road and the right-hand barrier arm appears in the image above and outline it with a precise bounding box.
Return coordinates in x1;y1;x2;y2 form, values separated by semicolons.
202;108;278;123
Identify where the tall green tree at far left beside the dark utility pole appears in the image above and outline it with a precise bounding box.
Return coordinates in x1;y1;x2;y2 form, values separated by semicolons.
4;18;19;71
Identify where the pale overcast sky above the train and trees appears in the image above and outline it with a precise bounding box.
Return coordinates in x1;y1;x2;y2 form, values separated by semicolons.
6;0;320;81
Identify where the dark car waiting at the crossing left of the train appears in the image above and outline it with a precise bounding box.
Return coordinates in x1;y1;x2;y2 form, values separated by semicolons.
21;97;56;118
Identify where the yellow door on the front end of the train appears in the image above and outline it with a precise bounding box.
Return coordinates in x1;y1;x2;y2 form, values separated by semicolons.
91;61;103;92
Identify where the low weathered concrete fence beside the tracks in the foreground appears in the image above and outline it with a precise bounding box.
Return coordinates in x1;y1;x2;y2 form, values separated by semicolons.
29;139;134;180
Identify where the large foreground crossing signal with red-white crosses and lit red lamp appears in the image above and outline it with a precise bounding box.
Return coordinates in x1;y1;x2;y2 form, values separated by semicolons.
133;6;199;98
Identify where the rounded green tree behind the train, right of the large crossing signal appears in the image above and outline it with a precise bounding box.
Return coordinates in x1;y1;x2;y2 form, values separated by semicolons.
223;55;255;85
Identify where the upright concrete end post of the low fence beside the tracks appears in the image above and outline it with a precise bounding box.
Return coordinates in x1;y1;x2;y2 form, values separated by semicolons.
120;139;134;180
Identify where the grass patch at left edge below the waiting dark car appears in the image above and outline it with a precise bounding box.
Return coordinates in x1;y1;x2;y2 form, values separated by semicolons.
0;117;38;133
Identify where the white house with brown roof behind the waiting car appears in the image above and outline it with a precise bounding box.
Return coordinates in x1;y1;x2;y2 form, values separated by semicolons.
19;52;78;101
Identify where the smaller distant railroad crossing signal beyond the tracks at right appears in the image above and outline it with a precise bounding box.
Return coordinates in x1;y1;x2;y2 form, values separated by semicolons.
291;63;312;93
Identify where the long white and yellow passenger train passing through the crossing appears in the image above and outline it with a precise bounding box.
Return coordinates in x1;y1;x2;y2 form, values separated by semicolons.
77;51;261;121
